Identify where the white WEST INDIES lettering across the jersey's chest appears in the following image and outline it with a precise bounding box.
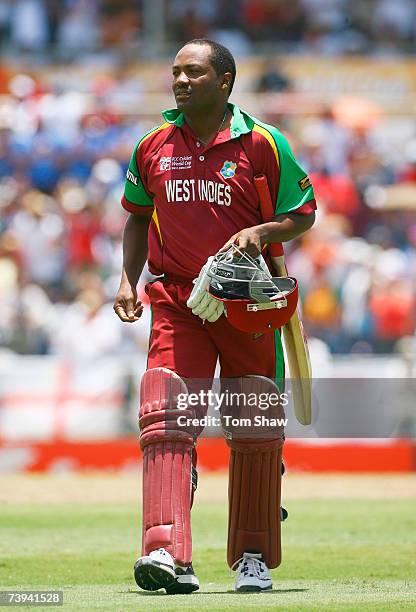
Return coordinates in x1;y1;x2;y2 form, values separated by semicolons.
165;179;231;206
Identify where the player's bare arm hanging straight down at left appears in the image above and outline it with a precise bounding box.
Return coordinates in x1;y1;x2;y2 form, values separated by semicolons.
113;215;150;323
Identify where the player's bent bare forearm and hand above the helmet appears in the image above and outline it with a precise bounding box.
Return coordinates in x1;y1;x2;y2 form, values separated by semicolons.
223;213;315;257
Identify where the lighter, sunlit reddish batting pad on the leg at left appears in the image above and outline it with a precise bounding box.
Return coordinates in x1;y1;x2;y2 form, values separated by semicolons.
139;368;194;565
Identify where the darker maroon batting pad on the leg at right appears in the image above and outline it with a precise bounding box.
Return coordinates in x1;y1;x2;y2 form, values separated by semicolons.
225;376;284;568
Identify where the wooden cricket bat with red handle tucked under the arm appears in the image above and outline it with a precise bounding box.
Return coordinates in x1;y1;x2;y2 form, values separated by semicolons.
254;174;312;425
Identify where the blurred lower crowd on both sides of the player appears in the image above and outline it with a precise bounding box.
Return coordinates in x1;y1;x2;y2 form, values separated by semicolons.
0;55;416;359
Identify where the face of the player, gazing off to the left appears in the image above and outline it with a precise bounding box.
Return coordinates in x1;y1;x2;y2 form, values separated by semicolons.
172;44;231;112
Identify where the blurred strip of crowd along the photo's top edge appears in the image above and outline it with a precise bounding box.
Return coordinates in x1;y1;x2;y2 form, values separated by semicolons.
0;0;416;60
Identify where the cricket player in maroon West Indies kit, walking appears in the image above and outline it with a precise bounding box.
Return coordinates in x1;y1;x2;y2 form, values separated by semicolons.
114;39;316;594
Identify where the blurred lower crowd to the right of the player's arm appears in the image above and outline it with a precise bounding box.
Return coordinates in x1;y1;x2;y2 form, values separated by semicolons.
289;103;416;353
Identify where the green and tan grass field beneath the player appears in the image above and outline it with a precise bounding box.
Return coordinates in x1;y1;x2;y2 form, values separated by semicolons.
0;475;416;612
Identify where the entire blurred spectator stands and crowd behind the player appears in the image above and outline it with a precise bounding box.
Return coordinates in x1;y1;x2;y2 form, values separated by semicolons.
0;0;416;469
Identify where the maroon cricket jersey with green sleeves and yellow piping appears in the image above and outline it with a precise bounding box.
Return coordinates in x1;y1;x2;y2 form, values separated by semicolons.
122;104;316;279
